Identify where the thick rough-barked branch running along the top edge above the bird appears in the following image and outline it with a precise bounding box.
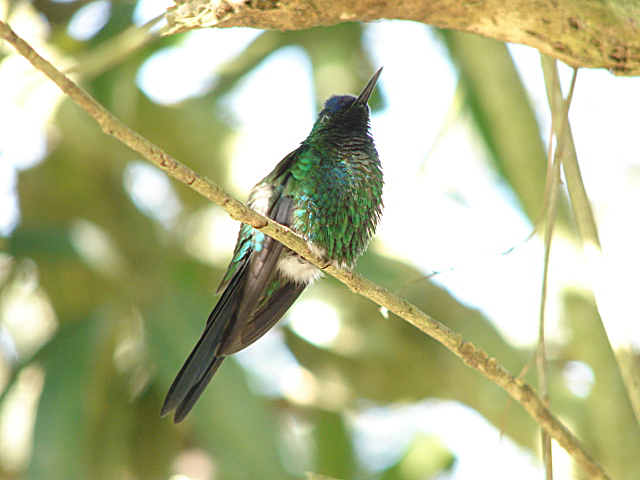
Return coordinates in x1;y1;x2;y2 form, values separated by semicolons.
163;0;640;75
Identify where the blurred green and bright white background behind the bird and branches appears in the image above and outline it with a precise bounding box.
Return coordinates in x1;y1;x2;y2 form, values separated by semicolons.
0;0;640;480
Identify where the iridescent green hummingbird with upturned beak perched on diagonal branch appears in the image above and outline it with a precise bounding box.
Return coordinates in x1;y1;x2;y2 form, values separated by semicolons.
161;68;383;423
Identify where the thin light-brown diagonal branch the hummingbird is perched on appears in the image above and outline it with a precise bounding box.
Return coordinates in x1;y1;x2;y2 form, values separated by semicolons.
0;21;610;480
